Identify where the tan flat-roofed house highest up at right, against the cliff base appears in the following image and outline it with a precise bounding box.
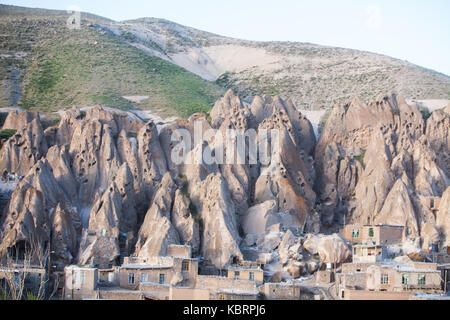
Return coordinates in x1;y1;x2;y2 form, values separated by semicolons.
340;224;404;245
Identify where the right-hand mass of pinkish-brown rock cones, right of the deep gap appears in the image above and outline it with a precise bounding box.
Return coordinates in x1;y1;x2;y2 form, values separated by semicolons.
315;94;450;249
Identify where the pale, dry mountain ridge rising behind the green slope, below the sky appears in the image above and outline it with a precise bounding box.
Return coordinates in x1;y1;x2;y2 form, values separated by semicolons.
0;6;450;116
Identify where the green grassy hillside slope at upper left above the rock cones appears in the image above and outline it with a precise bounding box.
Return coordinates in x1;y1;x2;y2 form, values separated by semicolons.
0;7;223;117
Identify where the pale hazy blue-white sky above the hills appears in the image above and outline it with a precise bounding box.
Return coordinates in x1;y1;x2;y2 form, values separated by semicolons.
0;0;450;75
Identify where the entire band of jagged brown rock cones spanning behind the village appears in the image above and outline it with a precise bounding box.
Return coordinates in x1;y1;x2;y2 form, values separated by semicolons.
0;91;450;277
